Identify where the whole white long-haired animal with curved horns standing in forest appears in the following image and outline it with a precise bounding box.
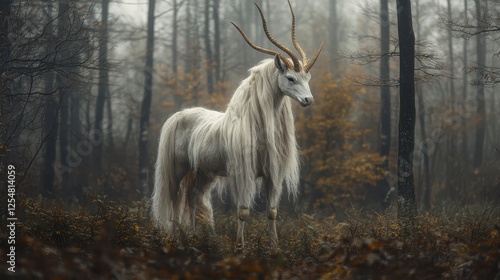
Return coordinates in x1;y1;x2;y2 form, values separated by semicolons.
152;1;323;248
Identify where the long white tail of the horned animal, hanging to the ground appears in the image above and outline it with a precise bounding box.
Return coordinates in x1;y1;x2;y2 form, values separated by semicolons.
151;115;185;234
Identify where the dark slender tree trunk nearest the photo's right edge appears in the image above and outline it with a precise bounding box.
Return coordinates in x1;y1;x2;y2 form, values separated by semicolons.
474;0;486;169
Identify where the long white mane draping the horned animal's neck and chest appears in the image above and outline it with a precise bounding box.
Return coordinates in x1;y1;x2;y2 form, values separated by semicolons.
189;59;299;205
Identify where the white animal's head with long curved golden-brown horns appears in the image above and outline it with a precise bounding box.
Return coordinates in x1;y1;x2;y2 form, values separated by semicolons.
231;0;323;107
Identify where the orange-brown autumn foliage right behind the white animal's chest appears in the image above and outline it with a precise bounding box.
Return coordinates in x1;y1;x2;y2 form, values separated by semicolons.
296;71;384;208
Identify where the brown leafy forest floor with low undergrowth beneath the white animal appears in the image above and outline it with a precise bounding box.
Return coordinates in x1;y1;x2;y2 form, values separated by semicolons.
0;197;500;279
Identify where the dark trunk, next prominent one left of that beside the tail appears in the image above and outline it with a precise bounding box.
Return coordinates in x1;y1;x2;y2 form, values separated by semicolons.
93;0;109;177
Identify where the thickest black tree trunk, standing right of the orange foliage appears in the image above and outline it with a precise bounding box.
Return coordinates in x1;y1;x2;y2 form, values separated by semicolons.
396;0;416;236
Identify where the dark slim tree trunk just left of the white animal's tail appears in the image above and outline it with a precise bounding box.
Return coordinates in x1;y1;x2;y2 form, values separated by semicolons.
139;0;156;195
